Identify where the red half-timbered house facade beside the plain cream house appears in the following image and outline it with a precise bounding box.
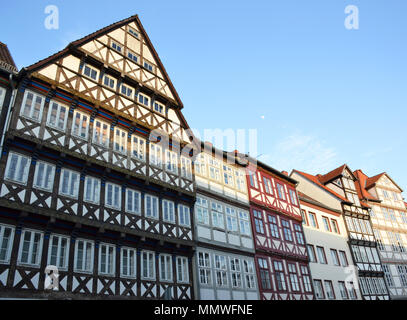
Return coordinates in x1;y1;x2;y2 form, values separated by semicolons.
246;160;314;300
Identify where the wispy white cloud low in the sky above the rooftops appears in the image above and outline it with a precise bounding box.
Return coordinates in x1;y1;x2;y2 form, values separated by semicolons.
259;133;338;174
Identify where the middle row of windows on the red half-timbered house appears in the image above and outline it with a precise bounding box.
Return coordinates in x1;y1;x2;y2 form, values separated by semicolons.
253;210;305;245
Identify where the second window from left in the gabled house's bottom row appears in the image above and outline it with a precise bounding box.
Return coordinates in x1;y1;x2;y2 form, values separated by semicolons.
18;230;43;267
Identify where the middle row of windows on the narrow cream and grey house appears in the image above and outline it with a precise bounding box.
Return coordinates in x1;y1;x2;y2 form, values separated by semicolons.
195;196;251;236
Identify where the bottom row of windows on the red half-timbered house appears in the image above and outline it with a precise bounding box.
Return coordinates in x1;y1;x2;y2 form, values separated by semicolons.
257;258;312;292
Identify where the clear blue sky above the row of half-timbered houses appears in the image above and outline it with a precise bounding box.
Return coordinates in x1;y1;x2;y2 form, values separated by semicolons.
0;0;407;195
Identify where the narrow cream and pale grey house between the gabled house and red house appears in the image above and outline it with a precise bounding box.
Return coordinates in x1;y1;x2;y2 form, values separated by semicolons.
194;143;259;300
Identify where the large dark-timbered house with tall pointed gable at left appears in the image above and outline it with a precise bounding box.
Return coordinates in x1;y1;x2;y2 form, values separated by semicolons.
0;16;195;299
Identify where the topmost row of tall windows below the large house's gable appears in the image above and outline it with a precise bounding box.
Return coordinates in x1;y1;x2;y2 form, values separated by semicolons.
20;90;192;179
